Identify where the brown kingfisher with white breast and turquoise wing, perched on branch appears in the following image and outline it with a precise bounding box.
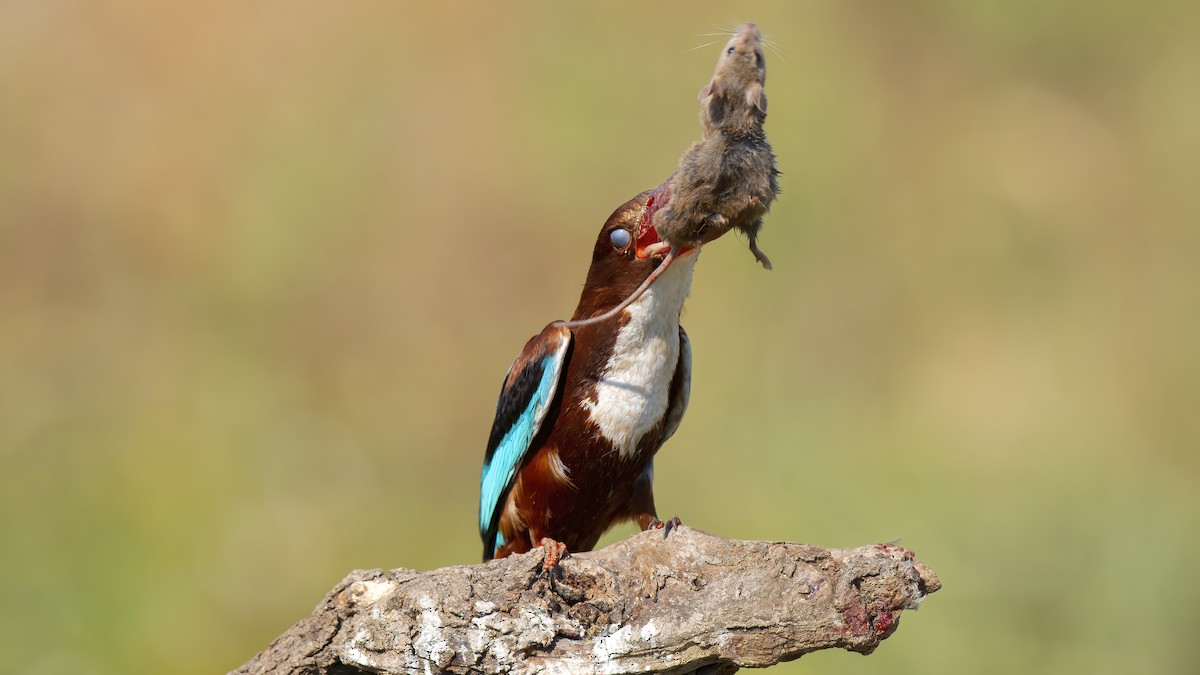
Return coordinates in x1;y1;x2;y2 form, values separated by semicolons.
479;185;700;564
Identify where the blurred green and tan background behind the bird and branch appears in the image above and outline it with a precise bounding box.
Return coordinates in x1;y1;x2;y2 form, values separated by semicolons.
0;0;1200;675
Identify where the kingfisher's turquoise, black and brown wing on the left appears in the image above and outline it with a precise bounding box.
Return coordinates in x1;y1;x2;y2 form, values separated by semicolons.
479;323;571;561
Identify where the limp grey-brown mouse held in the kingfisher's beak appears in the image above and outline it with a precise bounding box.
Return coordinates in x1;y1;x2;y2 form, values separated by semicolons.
654;22;779;269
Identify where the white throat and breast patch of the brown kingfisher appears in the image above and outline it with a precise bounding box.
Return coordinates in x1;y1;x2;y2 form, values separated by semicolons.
583;251;700;458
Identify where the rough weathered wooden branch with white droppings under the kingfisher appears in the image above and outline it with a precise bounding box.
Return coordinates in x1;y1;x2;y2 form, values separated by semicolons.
235;527;941;675
